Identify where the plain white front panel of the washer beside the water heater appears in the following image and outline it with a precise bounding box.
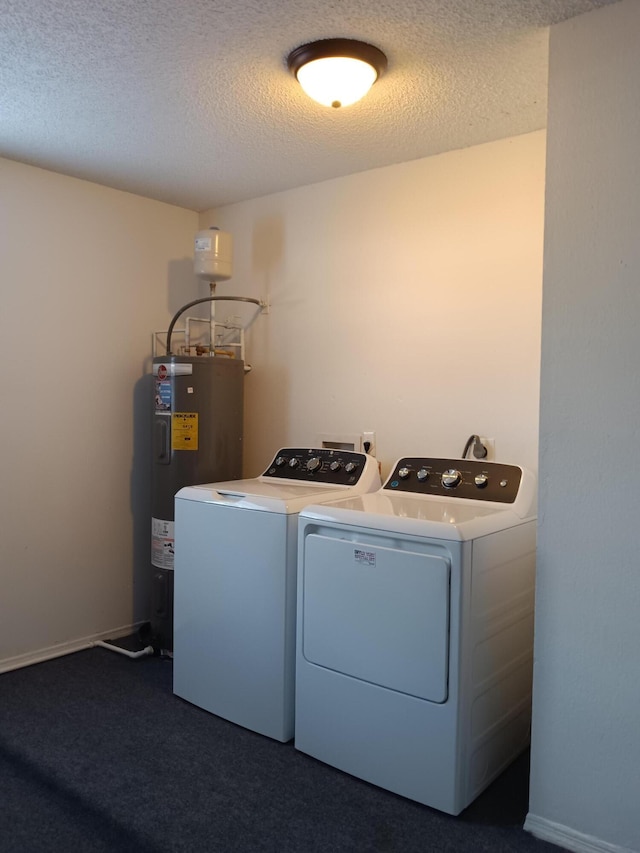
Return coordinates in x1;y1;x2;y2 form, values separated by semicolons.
173;499;297;741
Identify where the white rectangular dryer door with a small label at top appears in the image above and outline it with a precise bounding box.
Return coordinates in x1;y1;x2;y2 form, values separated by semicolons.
300;533;451;702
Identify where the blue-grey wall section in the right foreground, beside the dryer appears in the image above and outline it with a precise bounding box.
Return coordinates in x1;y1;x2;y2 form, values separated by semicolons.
527;0;640;852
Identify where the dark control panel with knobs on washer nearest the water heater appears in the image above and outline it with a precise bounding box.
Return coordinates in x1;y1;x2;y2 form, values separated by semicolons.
262;447;368;486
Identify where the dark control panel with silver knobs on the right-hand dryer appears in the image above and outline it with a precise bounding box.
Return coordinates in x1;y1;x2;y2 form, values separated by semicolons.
384;456;522;503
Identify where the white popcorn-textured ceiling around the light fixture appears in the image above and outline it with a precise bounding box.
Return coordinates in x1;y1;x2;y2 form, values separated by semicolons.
0;0;616;210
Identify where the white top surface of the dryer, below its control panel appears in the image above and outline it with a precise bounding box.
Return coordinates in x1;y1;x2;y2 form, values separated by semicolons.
301;490;522;541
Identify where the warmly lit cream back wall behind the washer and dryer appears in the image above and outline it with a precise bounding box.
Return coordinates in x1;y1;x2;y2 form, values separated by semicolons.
200;132;545;476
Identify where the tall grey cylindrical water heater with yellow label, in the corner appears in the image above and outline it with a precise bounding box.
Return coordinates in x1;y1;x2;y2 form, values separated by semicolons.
151;355;244;651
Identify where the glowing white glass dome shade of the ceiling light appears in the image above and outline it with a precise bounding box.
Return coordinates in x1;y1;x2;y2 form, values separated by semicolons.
297;56;378;107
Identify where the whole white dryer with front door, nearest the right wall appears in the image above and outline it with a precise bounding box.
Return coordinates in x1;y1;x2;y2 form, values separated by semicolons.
295;457;536;815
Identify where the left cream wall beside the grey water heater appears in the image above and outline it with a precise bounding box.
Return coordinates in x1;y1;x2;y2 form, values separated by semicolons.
0;160;198;670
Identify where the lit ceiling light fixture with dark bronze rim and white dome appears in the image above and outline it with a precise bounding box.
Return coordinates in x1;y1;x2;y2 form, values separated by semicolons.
287;39;387;107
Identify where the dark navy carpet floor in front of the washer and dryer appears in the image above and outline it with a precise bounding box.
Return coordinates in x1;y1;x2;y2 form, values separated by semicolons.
0;648;558;853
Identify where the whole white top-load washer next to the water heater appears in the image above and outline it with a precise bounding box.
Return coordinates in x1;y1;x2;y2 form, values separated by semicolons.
173;448;381;742
